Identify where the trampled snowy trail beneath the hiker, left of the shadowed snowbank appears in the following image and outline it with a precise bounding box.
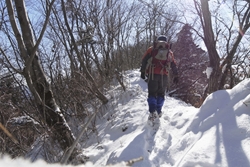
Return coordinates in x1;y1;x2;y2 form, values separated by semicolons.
84;72;201;167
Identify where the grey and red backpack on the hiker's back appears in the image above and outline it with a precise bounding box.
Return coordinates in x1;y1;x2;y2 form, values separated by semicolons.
146;41;173;79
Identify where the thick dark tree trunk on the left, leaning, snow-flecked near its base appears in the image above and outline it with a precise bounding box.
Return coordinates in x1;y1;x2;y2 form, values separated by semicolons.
6;0;75;159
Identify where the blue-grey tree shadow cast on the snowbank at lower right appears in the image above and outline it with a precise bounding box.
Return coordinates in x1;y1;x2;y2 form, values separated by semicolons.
187;90;250;167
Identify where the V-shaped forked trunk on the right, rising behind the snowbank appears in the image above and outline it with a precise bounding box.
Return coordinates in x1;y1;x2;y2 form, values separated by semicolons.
200;0;250;93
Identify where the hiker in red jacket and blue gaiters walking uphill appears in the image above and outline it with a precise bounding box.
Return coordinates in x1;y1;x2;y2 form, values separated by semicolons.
140;35;178;122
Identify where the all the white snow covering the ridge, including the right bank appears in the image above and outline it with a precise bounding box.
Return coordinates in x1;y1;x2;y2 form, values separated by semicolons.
0;70;250;167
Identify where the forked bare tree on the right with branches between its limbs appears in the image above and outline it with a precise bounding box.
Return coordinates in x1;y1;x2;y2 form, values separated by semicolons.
194;0;250;97
